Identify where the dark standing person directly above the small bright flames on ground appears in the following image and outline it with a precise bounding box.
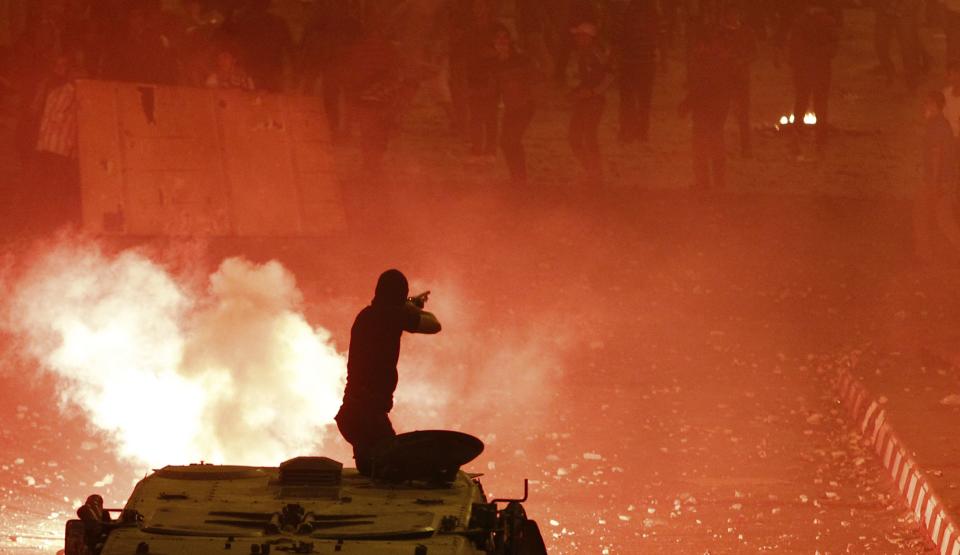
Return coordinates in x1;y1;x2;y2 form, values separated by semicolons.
787;0;839;151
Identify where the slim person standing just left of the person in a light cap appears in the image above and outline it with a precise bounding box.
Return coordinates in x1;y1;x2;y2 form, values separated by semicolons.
493;29;536;184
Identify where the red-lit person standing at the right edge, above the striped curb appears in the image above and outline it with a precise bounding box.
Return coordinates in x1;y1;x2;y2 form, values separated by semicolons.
913;91;960;263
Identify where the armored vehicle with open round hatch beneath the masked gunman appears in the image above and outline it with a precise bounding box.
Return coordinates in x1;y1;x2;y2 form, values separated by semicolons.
65;431;546;555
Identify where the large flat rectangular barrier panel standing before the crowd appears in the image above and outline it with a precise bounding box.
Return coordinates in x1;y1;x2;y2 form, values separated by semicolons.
77;80;345;237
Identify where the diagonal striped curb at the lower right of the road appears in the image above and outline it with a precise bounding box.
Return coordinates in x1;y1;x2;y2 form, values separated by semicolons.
836;369;960;555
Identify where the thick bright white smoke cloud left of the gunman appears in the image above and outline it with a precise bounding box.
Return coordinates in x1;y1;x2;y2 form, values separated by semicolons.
3;242;346;467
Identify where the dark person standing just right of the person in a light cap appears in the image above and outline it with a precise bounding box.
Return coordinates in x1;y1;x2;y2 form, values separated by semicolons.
615;0;662;143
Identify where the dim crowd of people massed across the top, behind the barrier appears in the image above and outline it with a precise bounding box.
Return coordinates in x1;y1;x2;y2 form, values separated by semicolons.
3;0;960;242
